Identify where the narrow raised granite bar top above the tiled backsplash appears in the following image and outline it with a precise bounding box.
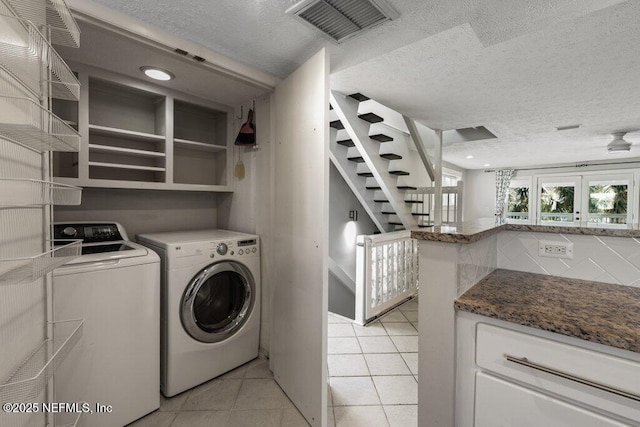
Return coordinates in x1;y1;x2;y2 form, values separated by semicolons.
411;220;640;243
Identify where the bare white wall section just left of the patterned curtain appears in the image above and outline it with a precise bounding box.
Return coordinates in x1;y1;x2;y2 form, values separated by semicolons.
462;170;496;221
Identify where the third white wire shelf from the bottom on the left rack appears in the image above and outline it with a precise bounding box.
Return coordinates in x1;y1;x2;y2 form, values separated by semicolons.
0;178;82;207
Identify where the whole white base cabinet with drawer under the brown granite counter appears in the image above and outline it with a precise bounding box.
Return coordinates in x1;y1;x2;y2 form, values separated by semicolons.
456;312;640;427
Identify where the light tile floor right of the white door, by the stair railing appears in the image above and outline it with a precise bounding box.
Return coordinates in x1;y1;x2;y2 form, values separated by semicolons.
327;298;418;427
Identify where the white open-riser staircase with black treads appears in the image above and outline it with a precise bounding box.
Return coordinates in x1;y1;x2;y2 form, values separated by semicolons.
330;92;432;233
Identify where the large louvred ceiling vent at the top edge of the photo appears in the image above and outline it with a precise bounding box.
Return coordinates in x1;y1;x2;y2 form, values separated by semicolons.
287;0;399;43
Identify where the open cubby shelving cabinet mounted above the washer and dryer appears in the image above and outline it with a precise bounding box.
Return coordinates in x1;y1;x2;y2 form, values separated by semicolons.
54;65;233;191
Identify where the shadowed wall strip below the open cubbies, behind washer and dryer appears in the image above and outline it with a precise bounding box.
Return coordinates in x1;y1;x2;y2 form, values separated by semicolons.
53;188;218;240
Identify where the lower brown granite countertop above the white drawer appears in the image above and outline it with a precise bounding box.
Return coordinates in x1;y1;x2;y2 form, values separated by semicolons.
455;270;640;353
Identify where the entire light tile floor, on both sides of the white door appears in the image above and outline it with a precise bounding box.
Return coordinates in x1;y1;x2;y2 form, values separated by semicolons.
129;299;418;427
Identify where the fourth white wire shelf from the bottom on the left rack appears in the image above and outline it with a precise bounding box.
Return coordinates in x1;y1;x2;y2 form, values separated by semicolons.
0;96;80;151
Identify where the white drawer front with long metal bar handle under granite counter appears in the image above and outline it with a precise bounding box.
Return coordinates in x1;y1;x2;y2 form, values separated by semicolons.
476;323;640;422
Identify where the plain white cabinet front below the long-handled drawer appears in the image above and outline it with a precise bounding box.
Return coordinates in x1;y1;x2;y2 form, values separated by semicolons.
474;373;625;427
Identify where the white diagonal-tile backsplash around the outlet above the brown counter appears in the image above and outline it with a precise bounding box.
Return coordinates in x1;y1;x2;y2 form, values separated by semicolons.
497;231;640;287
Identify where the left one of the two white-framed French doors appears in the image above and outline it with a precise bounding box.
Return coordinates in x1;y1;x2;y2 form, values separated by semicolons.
537;176;582;227
